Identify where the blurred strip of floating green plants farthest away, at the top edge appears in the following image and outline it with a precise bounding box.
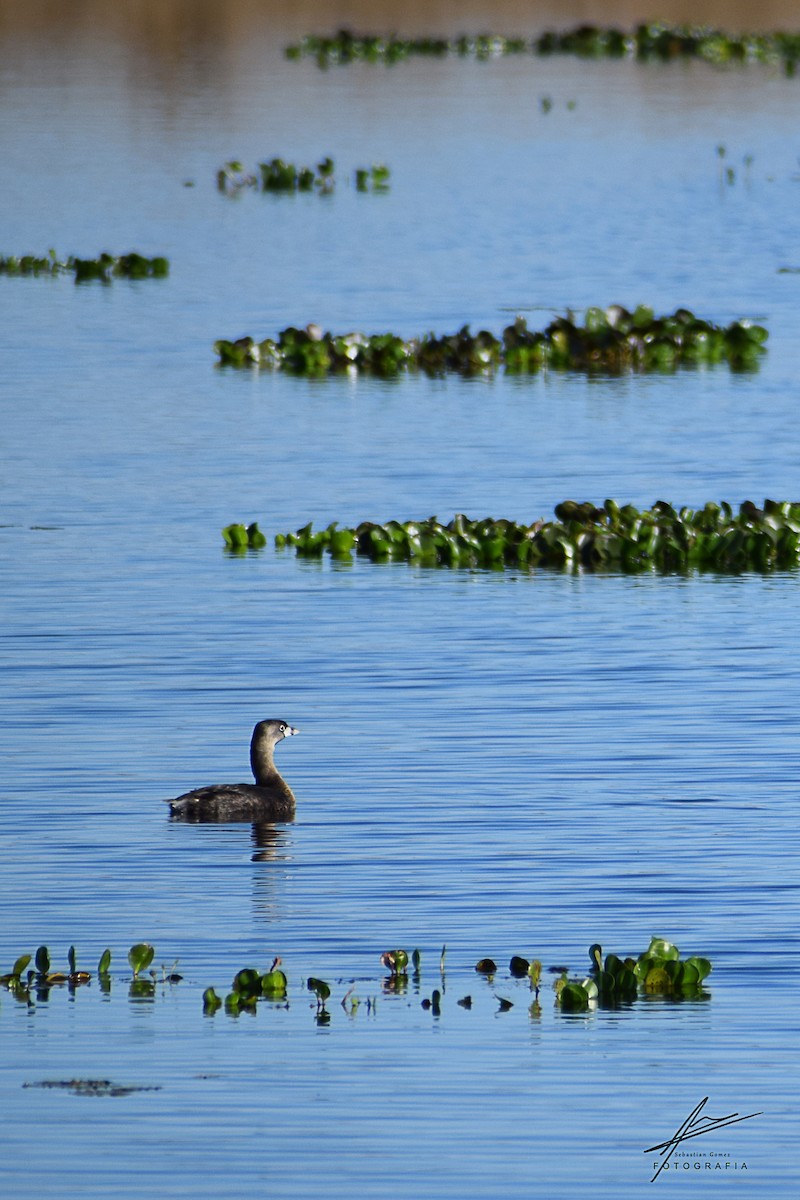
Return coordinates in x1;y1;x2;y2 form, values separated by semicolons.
284;22;800;74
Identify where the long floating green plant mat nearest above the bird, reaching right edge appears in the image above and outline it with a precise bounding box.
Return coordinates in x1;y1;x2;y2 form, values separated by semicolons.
222;500;800;572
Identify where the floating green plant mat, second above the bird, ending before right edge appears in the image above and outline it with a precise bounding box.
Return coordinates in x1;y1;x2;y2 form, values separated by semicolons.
213;305;769;377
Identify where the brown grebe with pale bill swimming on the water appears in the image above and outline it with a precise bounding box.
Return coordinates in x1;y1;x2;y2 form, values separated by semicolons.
167;719;300;821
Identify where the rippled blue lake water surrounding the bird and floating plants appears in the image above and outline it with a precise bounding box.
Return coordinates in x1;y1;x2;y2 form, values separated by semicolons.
0;0;800;1200
